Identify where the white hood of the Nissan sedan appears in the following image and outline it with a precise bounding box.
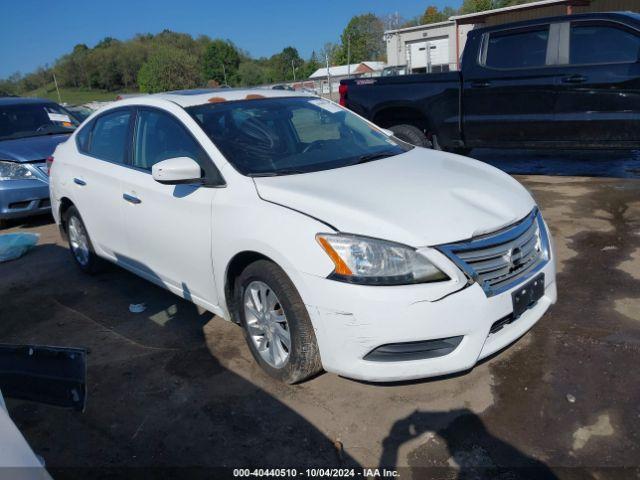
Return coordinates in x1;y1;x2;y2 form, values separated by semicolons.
254;148;535;247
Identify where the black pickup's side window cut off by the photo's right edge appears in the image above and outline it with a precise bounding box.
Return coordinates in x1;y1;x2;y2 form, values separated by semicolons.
569;22;640;65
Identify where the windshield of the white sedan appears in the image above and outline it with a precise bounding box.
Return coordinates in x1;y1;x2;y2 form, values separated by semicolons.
187;97;413;176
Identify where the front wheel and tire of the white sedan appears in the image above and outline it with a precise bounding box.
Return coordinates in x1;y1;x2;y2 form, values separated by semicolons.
235;260;322;384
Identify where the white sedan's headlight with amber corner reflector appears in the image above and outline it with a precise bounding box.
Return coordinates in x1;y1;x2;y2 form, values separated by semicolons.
316;233;449;285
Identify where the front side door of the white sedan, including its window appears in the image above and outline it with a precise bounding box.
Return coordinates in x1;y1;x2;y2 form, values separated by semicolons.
122;107;218;306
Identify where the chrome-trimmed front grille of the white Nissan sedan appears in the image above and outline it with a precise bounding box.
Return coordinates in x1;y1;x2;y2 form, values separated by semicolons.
439;208;549;297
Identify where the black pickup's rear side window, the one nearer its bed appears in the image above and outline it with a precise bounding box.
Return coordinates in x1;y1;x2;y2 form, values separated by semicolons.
484;26;549;68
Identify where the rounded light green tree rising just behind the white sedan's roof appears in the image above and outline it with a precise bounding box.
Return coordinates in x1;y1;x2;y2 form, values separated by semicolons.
138;46;201;93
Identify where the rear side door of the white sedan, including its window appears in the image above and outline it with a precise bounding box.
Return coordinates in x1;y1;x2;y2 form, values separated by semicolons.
64;107;134;261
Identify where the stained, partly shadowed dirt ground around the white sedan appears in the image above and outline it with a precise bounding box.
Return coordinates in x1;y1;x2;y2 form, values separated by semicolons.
0;176;640;479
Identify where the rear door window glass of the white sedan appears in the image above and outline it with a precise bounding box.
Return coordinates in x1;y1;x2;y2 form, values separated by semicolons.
89;109;131;163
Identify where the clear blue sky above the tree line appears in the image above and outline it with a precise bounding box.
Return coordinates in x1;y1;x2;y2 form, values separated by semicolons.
0;0;461;78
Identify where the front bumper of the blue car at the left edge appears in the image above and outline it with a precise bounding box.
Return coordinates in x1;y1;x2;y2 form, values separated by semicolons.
0;179;51;219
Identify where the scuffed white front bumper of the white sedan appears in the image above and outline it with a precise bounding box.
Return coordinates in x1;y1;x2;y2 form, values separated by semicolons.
301;261;557;382
